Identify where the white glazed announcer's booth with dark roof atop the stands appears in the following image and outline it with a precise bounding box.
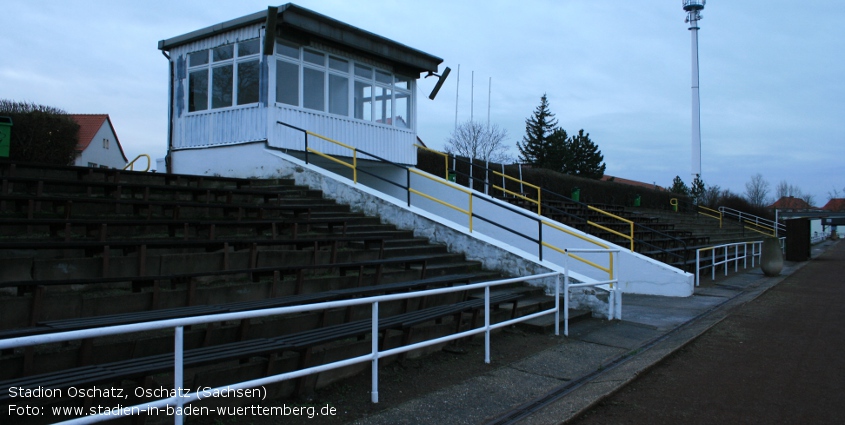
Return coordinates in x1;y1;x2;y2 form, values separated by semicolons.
158;4;443;177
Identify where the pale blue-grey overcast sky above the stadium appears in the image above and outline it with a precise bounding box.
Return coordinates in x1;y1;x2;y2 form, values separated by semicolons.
0;0;845;206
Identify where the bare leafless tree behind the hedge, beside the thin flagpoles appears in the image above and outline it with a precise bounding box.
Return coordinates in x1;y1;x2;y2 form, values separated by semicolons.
446;121;511;163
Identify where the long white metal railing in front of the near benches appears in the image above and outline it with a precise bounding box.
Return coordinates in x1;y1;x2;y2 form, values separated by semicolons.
0;272;568;425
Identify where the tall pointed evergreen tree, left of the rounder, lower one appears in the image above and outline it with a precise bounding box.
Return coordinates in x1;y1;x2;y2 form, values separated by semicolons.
516;93;557;168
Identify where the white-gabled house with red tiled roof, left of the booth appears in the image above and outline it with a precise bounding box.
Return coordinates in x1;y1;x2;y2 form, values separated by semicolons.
70;114;128;168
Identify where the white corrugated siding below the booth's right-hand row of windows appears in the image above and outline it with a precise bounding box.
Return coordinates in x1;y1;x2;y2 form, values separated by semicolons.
270;107;417;164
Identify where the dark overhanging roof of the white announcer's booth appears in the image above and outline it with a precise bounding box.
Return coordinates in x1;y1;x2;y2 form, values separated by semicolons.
158;3;443;73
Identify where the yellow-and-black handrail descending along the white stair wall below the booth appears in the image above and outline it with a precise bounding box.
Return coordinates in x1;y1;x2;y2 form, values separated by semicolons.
276;121;614;276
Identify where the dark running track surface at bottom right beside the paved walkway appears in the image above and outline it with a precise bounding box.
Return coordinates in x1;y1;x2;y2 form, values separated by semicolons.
568;241;845;425
